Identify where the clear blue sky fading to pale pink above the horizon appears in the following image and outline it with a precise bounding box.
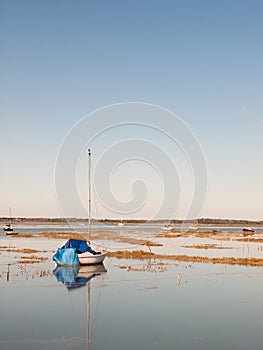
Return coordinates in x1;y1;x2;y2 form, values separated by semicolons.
0;0;263;220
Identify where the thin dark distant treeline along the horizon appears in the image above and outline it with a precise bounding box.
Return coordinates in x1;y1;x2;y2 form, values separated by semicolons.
0;217;263;226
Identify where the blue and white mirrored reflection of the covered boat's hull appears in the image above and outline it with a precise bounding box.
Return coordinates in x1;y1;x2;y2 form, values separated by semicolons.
53;264;107;290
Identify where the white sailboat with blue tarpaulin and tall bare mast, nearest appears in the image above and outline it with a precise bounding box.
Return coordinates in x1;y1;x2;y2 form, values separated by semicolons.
53;149;107;265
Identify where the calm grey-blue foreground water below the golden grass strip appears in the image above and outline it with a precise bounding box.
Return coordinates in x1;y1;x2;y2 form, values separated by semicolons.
0;243;263;350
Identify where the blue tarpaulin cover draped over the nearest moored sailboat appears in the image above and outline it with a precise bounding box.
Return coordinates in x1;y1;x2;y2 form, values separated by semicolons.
53;238;96;265
